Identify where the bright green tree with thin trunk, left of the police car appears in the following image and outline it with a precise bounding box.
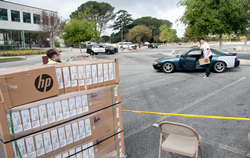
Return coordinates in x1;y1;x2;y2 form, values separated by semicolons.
60;19;95;53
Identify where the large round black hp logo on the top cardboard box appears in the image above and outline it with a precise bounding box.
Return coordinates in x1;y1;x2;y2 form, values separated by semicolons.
35;74;53;92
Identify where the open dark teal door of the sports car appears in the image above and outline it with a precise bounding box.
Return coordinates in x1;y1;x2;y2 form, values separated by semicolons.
179;51;197;71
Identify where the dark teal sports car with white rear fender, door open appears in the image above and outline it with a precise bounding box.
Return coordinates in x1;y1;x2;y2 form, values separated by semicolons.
153;48;240;73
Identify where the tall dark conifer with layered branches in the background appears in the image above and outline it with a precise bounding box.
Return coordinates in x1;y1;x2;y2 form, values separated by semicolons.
112;10;134;41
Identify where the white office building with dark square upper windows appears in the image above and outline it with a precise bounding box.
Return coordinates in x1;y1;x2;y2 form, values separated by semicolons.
0;0;56;49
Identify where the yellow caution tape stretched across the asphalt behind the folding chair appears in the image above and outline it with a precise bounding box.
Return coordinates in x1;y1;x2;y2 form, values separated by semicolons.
122;110;250;121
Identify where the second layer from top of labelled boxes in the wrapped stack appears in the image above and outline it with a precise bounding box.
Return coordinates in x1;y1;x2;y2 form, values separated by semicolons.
0;85;121;142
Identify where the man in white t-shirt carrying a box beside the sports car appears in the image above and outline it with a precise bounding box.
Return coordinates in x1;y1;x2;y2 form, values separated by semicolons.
198;37;213;78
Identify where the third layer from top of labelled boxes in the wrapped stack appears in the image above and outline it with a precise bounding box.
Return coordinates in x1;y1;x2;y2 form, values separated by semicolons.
0;104;124;158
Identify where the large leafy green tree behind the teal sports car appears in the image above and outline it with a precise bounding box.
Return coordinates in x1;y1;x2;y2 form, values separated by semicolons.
178;0;250;50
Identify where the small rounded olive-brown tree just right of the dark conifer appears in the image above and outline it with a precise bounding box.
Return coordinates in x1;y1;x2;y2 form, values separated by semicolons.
129;25;152;44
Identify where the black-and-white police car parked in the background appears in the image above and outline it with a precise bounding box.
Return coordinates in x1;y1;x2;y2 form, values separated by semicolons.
86;44;118;55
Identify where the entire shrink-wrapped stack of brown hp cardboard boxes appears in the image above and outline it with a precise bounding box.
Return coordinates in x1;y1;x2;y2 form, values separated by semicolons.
0;59;125;158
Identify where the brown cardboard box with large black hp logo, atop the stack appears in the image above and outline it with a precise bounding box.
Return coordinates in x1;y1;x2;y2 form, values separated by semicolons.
0;65;59;108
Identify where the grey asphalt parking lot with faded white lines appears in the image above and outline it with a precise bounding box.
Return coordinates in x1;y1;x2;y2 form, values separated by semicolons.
0;46;250;158
